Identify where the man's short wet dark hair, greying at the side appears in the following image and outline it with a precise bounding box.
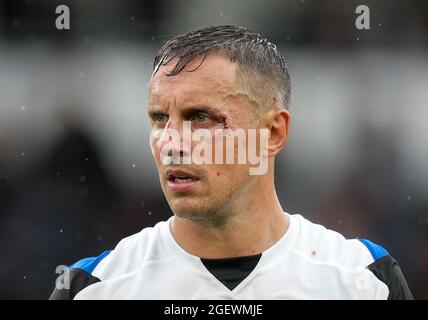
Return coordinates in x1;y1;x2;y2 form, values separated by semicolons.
152;25;291;109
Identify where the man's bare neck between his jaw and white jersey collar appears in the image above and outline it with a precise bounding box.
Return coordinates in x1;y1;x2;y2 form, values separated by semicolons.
171;172;289;258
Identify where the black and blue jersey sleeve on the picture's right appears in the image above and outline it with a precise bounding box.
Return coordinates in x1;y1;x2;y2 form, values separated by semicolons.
360;239;413;300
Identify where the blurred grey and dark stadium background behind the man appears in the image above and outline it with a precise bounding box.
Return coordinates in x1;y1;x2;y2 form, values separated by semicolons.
0;0;428;299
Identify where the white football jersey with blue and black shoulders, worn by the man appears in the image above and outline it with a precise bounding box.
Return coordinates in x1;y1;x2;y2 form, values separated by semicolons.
51;214;412;299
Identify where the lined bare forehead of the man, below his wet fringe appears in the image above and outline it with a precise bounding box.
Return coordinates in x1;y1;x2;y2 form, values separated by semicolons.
149;55;242;109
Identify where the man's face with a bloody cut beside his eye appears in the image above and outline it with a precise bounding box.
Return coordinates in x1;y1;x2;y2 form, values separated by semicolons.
148;55;258;221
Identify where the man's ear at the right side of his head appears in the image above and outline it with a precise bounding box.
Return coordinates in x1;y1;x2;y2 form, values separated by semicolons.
265;109;291;157
